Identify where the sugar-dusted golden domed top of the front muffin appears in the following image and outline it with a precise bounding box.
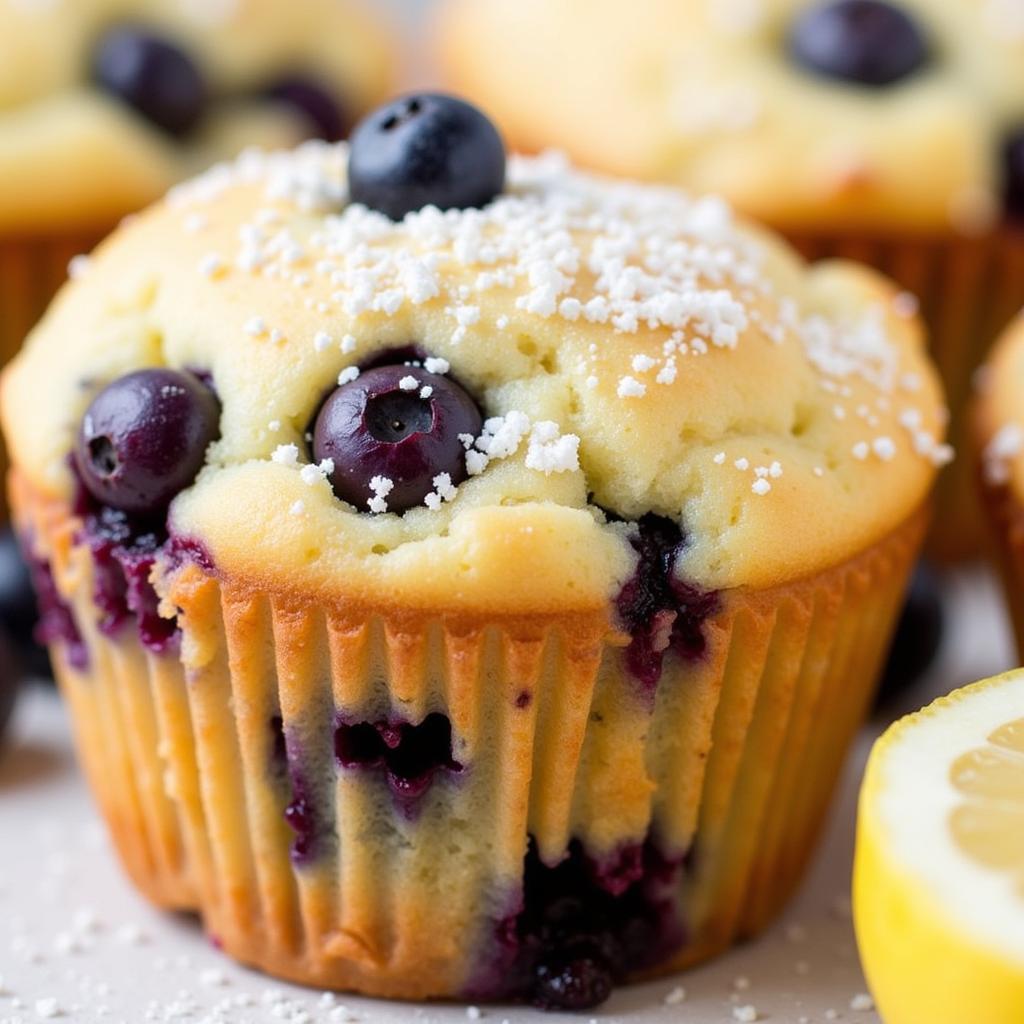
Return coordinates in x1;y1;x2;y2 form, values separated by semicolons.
2;139;949;612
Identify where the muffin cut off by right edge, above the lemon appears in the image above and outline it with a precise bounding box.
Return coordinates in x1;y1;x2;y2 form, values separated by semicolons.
974;307;1024;653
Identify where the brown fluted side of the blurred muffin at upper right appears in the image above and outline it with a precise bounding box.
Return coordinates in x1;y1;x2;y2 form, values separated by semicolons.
791;227;1024;561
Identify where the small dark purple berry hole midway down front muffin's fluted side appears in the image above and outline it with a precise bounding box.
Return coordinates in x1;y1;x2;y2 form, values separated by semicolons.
334;713;463;817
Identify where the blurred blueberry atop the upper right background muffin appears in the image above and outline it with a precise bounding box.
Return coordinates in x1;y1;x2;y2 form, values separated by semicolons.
790;0;930;87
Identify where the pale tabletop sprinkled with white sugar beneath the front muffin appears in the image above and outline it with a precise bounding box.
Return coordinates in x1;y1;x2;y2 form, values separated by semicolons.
0;574;1013;1024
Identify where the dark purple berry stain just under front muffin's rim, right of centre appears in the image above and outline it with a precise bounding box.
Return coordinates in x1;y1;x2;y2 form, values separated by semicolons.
615;514;719;695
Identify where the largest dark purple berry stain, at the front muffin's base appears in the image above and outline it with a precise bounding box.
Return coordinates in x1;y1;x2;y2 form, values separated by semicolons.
466;840;686;1011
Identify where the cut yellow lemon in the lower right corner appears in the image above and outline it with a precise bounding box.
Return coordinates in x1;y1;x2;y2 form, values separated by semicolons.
854;670;1024;1024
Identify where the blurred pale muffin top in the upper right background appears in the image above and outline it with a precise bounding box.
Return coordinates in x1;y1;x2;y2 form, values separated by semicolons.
438;0;1024;236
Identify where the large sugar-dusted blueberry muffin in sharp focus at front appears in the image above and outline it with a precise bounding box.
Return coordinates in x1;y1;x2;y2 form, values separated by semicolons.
2;94;948;1009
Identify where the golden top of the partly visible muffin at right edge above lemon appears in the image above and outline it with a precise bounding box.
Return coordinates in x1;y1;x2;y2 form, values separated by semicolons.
977;312;1024;498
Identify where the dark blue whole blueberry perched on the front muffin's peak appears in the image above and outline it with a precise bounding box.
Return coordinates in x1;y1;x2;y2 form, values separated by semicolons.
348;92;505;220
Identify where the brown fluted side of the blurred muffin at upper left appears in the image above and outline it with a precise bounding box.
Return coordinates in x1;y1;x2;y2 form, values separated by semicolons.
0;232;97;522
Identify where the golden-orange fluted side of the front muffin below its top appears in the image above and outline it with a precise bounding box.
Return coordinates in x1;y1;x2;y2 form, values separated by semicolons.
12;475;926;998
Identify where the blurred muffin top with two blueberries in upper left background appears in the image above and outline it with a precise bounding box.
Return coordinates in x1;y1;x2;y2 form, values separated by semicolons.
0;0;393;237
